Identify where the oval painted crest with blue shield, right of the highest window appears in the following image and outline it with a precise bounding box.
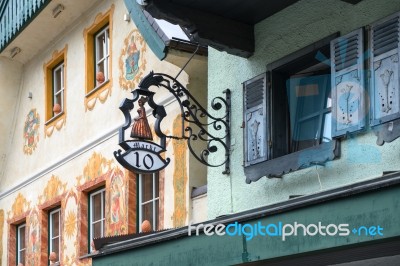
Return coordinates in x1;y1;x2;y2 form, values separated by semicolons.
119;29;147;90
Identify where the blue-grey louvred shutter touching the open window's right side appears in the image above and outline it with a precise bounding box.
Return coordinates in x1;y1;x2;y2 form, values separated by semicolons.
331;29;366;137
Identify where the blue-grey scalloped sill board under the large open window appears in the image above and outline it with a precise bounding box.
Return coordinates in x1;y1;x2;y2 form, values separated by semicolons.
244;140;340;184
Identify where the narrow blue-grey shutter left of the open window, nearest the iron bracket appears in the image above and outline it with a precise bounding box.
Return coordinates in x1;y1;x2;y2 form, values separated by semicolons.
243;73;268;166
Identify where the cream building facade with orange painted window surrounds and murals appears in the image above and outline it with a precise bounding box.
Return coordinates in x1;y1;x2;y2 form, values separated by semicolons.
0;0;207;265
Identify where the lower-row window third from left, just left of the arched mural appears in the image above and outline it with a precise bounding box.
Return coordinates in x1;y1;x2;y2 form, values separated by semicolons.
89;188;106;250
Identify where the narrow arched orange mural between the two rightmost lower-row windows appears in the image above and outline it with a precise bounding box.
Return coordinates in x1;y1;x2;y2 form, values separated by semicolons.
107;168;128;235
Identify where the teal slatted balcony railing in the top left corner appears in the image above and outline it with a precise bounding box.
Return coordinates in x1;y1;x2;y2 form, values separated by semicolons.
0;0;51;52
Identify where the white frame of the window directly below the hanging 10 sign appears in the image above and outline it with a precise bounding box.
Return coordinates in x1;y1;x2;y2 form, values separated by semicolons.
138;173;160;232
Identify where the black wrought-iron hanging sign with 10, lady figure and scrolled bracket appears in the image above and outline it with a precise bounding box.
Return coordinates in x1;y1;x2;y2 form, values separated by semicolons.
114;72;230;174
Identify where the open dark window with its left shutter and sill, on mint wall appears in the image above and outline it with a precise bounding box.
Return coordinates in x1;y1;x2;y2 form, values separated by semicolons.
243;35;354;183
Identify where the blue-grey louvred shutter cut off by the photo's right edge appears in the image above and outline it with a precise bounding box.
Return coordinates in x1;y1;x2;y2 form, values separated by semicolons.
370;13;400;126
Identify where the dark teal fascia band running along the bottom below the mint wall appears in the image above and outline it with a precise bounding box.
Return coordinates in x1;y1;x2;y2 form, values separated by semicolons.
93;185;400;266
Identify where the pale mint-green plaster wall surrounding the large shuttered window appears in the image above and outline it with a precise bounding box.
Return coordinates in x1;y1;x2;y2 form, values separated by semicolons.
207;0;400;219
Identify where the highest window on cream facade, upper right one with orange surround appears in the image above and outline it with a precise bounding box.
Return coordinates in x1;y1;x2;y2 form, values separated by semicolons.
94;25;110;87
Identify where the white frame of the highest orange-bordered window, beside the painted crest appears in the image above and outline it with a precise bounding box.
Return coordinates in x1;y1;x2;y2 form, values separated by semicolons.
94;24;110;87
